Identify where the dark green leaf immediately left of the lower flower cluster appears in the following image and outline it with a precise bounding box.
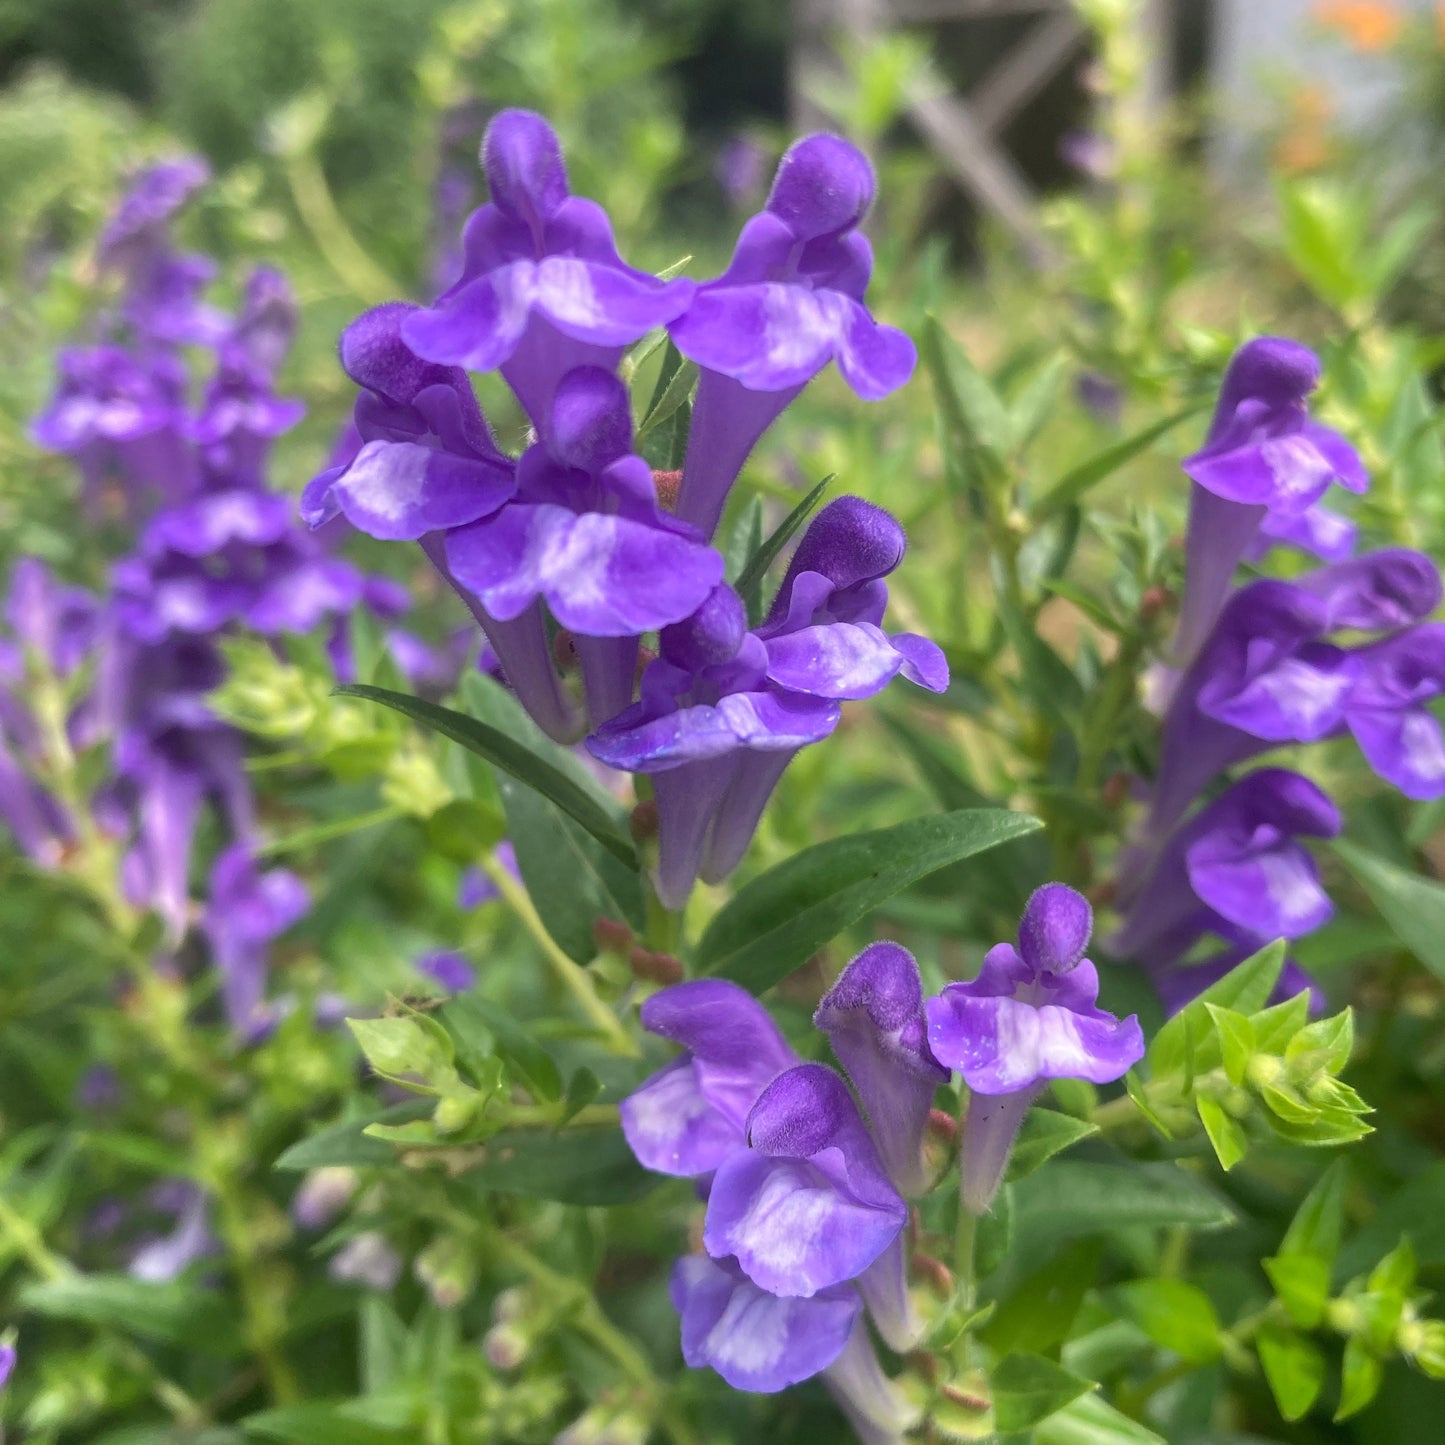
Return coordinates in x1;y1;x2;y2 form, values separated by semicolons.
454;1129;662;1204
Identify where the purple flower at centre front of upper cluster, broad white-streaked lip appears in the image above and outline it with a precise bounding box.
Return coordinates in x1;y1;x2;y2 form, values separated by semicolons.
447;367;723;724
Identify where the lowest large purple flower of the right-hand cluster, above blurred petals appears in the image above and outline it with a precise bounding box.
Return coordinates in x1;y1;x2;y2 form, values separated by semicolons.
1111;767;1340;972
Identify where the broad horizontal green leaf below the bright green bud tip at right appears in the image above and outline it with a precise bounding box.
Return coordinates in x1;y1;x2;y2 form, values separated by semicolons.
1013;1159;1234;1247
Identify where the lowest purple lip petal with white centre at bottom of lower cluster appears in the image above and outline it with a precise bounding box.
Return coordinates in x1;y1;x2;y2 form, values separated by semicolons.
672;1254;863;1394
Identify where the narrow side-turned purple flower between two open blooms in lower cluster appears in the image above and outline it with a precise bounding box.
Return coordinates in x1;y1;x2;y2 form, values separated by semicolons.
814;942;948;1195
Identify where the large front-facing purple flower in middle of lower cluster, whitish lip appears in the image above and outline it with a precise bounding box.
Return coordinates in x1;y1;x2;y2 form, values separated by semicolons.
702;1064;907;1299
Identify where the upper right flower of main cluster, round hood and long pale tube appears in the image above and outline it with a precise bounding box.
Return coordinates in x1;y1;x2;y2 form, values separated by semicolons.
669;136;916;536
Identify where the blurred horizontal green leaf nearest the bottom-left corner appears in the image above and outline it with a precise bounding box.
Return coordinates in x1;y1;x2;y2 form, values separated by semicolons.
19;1274;244;1360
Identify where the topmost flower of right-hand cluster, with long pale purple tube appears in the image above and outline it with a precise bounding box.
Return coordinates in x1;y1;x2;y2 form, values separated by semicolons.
1175;337;1368;666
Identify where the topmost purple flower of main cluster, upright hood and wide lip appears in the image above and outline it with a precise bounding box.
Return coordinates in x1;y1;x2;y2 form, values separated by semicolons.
405;110;694;432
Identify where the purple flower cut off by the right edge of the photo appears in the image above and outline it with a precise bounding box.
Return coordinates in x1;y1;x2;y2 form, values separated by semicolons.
1345;623;1445;799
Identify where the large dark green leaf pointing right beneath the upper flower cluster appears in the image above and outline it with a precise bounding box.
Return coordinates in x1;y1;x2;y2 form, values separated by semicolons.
696;808;1039;993
